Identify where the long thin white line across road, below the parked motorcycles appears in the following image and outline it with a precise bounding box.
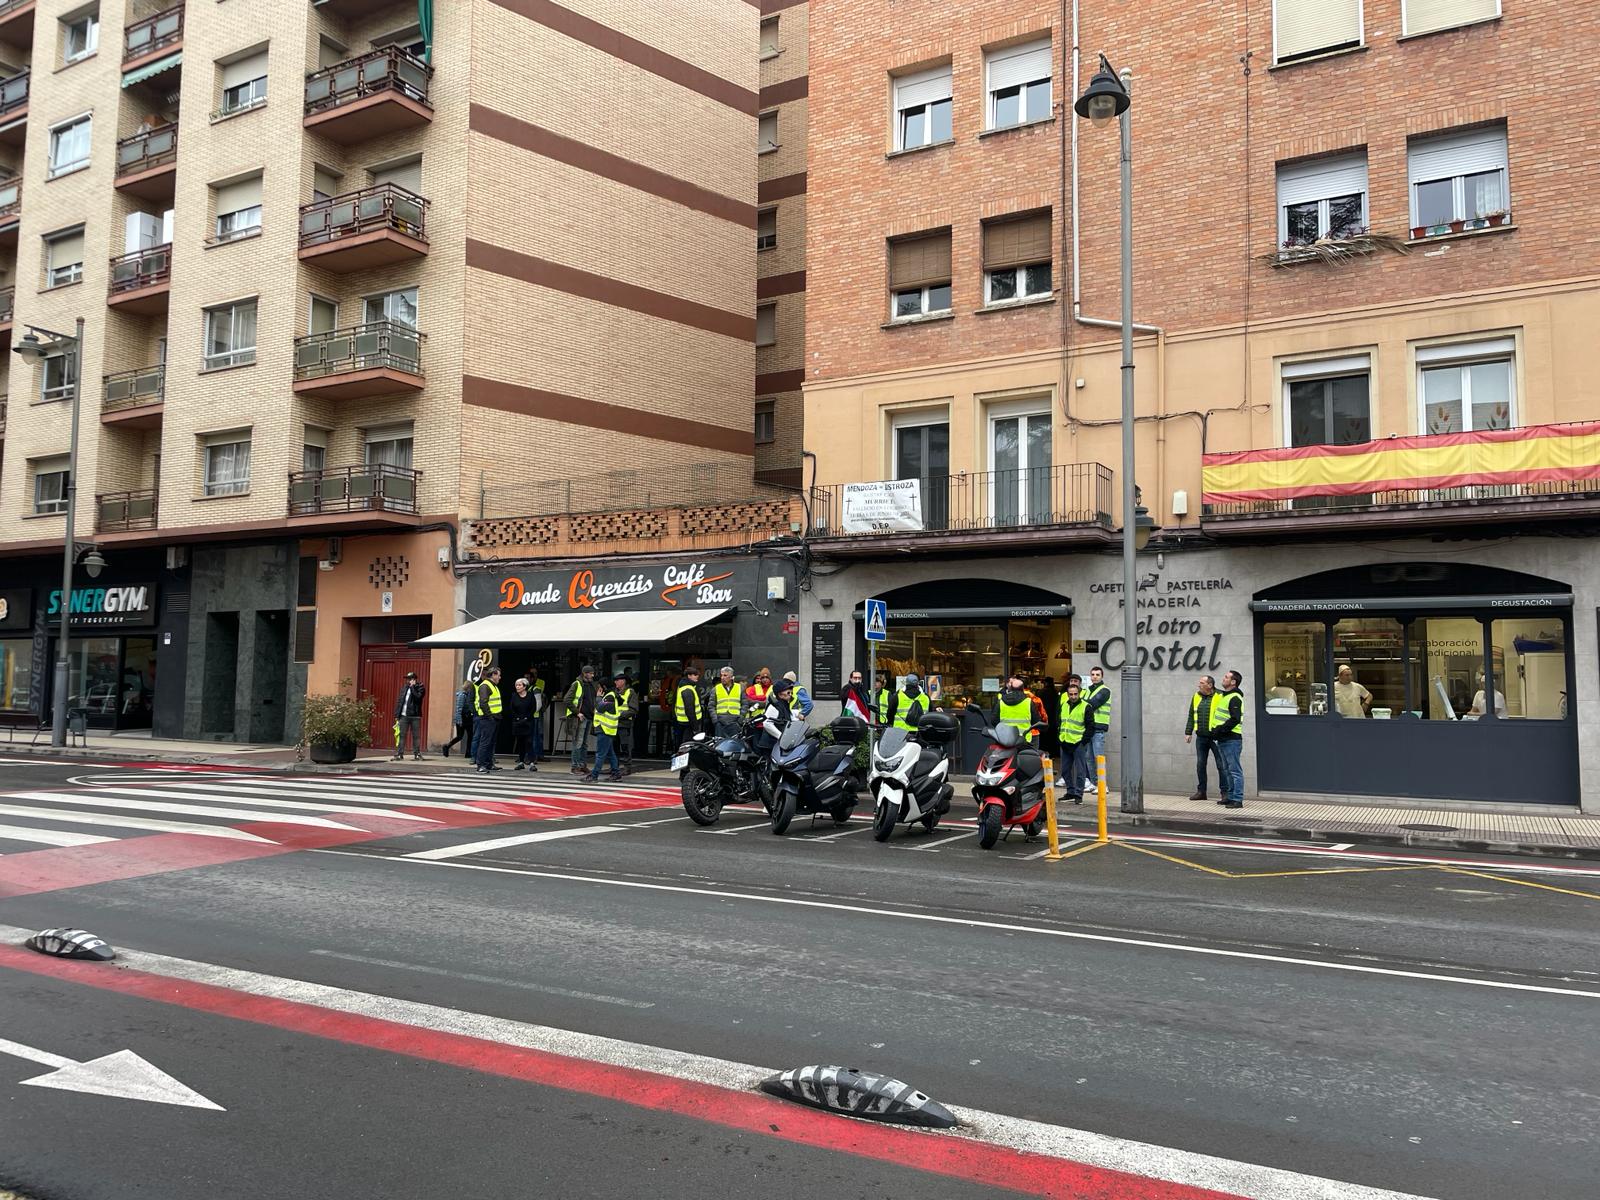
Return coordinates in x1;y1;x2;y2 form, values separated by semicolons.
310;857;1600;1000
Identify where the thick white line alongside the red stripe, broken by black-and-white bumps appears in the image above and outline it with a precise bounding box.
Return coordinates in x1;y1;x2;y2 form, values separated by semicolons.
0;928;1422;1200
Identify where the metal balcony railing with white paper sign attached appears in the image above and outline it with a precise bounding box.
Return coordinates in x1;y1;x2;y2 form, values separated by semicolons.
811;462;1112;538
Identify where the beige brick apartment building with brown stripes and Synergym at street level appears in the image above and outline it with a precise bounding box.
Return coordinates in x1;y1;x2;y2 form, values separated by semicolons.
0;0;757;744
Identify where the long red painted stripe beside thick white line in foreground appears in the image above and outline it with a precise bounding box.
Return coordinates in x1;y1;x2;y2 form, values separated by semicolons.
0;946;1237;1200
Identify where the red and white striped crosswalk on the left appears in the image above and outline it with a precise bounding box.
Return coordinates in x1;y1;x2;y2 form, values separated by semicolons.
0;768;677;872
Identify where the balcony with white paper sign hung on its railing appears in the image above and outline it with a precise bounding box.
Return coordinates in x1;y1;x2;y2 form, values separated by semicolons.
811;462;1117;555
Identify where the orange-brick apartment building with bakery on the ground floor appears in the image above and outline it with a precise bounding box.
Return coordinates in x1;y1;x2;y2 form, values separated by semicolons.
802;0;1600;808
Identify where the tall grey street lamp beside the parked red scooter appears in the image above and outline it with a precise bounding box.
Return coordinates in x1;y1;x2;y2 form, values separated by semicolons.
1072;54;1155;813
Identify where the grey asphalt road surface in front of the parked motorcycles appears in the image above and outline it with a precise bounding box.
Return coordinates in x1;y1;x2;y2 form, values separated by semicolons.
0;765;1600;1200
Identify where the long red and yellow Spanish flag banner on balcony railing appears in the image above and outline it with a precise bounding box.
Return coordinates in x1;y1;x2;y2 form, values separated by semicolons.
1202;421;1600;504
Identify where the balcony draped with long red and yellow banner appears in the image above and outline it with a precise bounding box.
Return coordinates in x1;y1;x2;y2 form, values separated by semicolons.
1200;421;1600;538
